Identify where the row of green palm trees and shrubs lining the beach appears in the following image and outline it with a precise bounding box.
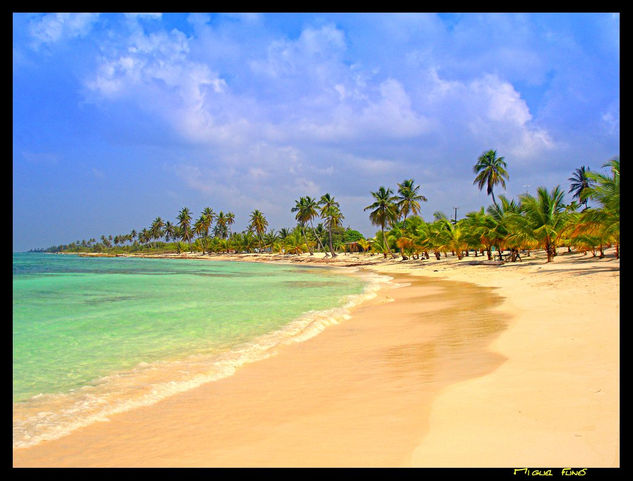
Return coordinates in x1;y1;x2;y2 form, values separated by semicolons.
34;150;620;262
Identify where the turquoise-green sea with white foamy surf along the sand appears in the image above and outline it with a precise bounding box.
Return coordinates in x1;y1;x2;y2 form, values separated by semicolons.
13;253;388;447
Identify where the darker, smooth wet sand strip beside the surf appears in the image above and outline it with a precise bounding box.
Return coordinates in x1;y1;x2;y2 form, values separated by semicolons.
14;275;507;467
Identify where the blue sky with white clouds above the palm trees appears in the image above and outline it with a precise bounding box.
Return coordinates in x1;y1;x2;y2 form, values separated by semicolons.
12;12;620;252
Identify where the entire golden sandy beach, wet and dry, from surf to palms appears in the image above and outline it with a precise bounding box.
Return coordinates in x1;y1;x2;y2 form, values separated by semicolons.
13;249;620;468
